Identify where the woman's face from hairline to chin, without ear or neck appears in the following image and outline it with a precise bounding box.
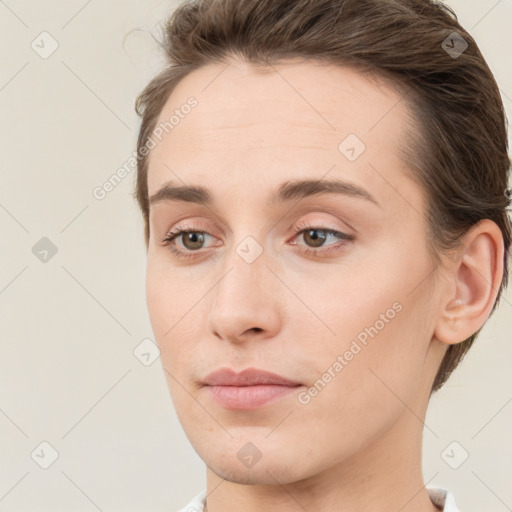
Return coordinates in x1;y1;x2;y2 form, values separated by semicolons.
146;60;440;484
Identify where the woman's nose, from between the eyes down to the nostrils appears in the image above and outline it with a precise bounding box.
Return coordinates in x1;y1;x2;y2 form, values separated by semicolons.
208;239;283;343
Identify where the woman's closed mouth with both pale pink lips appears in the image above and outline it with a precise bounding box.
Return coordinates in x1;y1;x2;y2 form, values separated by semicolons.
203;368;302;409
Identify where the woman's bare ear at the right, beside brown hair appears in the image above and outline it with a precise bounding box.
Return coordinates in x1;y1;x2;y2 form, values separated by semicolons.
434;219;504;345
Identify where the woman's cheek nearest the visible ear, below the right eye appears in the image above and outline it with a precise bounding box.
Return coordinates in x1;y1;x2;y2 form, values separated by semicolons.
297;251;432;406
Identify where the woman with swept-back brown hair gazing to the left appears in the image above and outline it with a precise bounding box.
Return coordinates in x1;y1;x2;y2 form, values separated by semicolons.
131;0;511;512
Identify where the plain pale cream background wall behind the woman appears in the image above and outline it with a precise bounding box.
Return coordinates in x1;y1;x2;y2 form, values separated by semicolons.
0;0;512;512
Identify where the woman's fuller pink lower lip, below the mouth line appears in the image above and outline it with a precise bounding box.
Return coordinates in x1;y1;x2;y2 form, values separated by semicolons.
208;384;299;409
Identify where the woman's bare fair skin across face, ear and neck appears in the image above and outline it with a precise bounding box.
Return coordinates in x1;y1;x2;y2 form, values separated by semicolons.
146;58;503;512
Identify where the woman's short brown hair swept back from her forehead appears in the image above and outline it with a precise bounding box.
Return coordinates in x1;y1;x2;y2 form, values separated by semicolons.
135;0;511;392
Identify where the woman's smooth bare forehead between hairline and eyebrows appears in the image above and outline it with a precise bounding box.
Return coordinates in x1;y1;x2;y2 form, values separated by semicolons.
148;59;416;200
